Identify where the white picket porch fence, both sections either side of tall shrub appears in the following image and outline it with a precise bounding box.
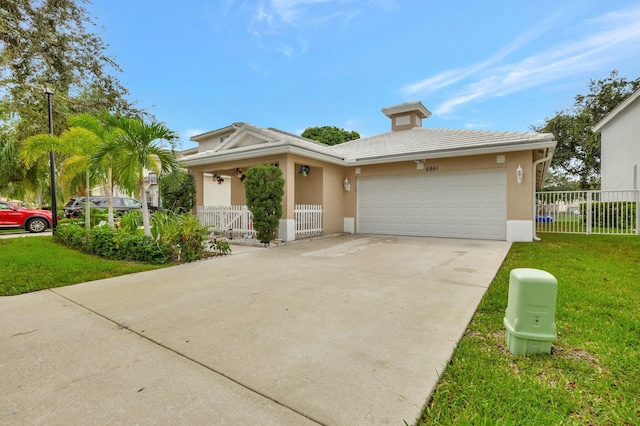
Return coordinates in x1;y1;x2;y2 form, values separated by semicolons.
197;204;322;236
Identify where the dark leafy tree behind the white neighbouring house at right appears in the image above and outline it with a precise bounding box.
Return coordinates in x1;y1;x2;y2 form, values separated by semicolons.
533;71;640;189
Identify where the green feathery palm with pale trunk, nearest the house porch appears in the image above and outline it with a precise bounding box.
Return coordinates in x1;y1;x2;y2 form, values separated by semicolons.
93;116;180;235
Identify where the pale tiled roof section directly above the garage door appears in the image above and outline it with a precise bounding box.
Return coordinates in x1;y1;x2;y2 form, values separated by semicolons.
333;127;553;160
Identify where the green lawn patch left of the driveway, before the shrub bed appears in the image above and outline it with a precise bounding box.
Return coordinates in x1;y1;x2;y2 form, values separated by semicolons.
0;236;168;296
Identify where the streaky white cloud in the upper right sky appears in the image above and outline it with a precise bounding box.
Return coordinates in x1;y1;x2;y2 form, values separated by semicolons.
400;6;640;115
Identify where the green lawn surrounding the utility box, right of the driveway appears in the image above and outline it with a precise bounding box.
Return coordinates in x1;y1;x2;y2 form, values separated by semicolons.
418;234;640;425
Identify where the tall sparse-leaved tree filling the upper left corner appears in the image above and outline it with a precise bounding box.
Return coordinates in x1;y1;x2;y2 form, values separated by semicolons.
0;0;140;199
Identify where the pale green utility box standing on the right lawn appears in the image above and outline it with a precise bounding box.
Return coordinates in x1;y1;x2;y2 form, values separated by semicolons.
504;268;558;355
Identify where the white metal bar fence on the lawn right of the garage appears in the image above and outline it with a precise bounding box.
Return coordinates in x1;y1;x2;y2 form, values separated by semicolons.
535;190;640;235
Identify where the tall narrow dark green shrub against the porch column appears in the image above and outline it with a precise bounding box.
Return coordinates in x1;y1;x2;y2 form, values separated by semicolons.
244;165;284;243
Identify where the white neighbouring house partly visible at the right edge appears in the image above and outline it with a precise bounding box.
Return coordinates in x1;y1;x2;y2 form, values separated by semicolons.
593;90;640;191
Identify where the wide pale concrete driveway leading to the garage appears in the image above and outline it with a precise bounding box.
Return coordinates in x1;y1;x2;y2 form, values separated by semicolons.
0;235;510;425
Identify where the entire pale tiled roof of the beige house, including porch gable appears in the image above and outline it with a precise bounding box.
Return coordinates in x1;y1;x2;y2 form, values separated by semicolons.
182;120;556;166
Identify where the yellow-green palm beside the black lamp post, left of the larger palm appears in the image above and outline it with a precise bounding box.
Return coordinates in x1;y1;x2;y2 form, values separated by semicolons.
19;127;100;228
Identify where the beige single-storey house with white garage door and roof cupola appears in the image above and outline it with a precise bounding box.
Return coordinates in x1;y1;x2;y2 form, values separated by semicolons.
182;102;556;241
